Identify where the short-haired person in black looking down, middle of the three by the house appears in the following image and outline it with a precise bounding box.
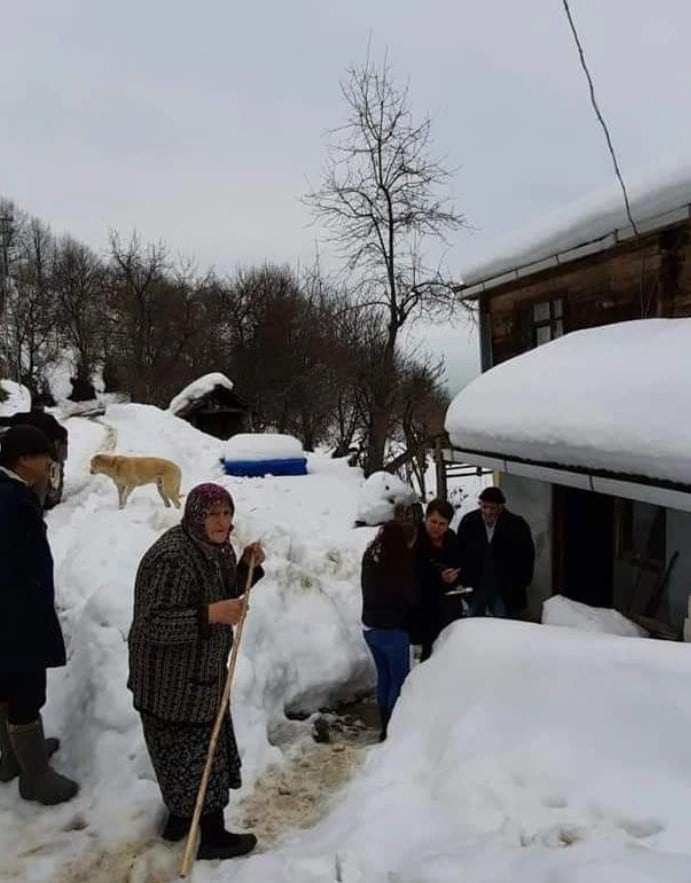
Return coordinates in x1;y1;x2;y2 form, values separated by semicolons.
410;500;464;662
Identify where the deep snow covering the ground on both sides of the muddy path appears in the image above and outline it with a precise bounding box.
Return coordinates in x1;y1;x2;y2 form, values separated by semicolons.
0;405;691;883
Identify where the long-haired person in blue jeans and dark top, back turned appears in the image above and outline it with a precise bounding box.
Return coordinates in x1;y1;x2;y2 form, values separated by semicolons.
361;521;415;741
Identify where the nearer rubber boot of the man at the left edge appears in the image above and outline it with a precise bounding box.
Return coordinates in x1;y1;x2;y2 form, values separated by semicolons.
8;717;79;806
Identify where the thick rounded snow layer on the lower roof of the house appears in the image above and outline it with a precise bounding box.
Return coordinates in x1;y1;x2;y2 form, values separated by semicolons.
446;319;691;486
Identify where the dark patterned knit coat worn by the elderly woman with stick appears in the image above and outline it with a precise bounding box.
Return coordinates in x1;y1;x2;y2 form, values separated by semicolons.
127;525;263;723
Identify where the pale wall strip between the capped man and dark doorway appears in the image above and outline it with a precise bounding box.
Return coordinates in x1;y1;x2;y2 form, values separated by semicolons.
500;474;552;614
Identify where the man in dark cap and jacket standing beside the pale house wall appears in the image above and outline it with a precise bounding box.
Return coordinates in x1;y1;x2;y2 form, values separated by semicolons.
458;487;535;618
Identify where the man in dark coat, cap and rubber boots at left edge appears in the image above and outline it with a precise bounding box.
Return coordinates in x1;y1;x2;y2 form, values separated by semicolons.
0;426;78;806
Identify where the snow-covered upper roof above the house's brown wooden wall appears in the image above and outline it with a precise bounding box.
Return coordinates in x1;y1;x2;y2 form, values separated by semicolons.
462;160;691;296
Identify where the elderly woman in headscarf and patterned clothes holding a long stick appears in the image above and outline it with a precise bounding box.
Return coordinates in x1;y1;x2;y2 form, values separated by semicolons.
128;484;264;859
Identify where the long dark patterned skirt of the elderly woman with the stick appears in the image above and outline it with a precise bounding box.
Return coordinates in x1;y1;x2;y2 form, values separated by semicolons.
141;712;242;818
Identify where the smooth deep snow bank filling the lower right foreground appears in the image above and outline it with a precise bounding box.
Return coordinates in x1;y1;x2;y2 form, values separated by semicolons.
223;619;691;883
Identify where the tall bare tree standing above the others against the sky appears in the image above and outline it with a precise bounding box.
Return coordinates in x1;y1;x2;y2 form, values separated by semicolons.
305;57;465;472
